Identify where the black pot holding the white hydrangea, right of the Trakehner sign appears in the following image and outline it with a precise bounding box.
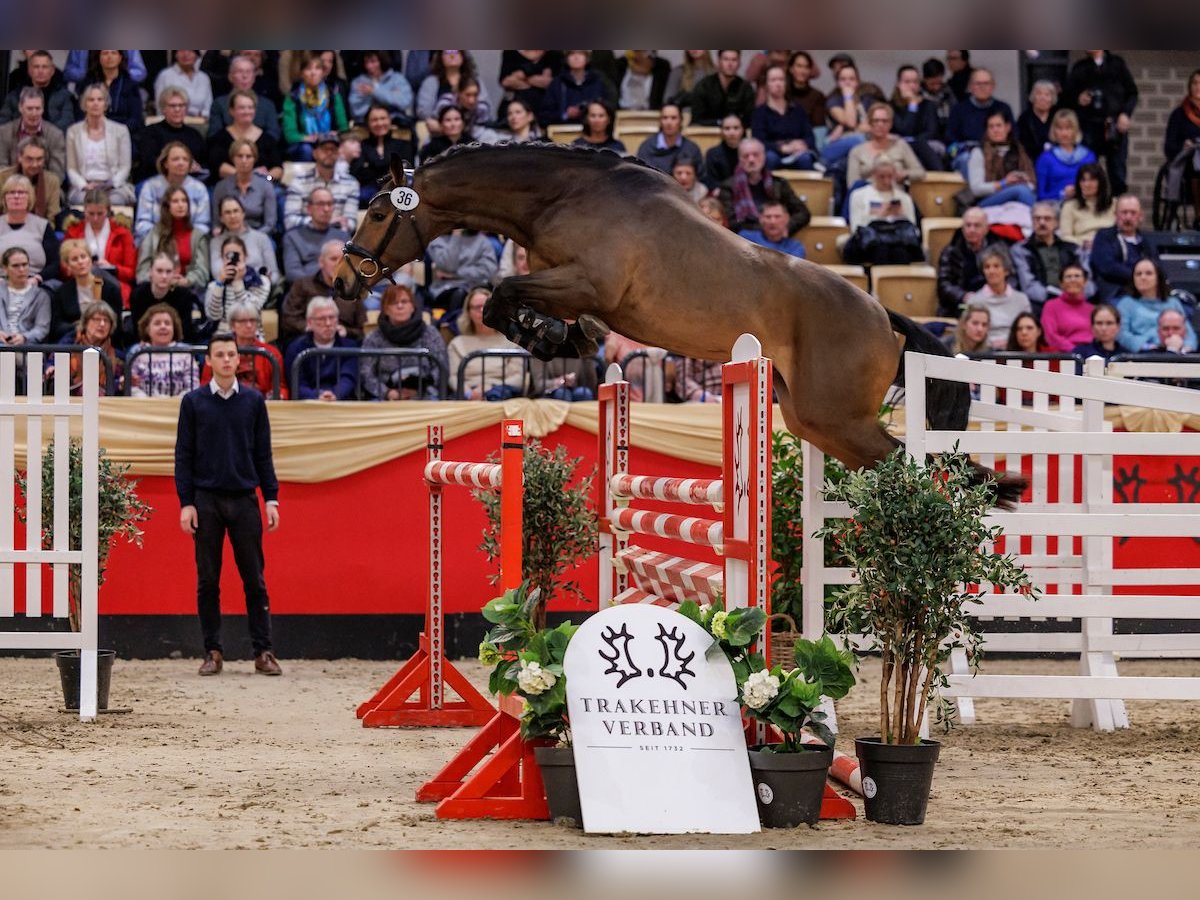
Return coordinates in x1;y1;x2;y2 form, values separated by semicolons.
749;744;833;828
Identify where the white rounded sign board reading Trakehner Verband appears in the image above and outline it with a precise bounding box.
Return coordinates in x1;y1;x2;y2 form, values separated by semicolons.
564;604;758;834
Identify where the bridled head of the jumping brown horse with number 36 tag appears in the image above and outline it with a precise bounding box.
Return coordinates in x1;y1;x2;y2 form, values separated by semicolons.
334;156;428;300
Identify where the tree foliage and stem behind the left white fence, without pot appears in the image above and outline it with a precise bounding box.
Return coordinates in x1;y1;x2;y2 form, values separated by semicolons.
17;439;154;631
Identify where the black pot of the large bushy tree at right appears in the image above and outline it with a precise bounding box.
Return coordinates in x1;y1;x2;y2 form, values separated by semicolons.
854;738;942;824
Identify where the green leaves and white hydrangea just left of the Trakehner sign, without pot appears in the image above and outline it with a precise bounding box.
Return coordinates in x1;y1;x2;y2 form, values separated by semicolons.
479;582;578;745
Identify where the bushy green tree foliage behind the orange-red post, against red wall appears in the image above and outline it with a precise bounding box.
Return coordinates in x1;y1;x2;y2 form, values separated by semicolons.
473;440;599;625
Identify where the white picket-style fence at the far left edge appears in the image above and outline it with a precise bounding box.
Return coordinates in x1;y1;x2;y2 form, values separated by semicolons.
0;350;100;721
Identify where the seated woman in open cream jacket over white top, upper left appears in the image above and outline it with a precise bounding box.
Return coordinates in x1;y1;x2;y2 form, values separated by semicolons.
66;84;134;206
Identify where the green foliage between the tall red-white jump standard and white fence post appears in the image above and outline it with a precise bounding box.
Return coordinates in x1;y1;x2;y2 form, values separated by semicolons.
770;431;846;622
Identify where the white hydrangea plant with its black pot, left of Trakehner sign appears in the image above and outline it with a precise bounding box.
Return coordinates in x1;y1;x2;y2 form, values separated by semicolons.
479;581;583;824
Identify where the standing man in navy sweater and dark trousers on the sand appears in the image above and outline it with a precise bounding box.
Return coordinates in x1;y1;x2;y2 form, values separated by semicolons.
175;332;283;676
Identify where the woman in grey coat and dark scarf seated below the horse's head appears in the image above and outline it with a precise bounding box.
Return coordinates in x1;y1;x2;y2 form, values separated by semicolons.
360;278;450;400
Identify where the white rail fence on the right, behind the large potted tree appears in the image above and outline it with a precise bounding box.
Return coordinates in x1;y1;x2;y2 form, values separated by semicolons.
802;353;1200;731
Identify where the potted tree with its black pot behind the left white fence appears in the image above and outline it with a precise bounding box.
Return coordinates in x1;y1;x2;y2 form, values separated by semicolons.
17;439;154;709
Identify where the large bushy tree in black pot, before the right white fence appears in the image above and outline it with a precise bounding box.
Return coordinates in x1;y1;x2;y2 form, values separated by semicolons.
818;450;1032;824
